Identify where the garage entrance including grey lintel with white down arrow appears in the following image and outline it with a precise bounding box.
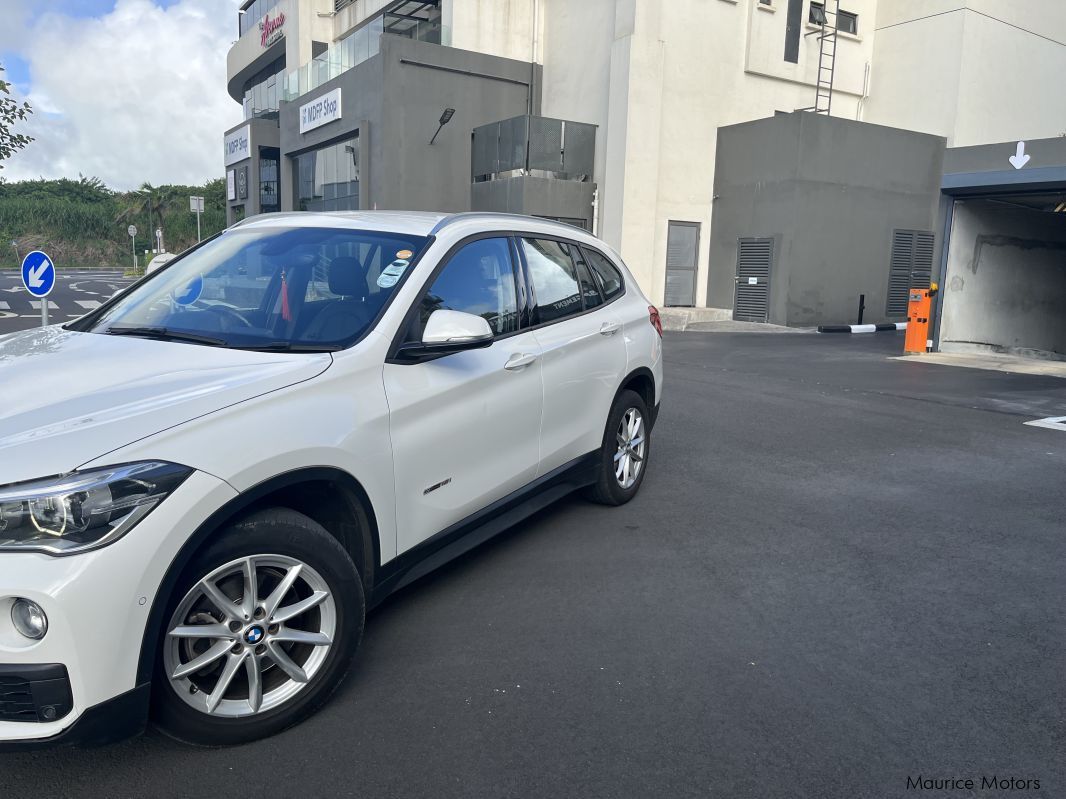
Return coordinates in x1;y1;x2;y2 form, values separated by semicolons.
936;140;1066;361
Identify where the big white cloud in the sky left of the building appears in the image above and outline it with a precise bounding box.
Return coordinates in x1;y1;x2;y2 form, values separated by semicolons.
0;0;241;189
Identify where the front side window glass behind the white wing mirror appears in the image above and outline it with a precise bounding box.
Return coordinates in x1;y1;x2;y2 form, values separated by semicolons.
417;238;518;338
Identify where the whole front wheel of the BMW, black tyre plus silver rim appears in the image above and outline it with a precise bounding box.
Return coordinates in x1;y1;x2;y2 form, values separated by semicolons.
152;508;366;746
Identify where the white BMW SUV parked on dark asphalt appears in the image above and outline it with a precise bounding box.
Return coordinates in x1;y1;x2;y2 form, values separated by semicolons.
0;212;662;750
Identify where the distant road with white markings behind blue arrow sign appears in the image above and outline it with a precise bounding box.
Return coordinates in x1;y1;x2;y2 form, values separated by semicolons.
0;270;133;335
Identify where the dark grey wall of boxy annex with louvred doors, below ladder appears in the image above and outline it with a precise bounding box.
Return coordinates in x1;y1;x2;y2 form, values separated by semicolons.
707;112;944;326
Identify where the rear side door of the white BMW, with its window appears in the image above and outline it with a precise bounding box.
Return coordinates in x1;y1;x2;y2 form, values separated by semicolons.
518;235;627;474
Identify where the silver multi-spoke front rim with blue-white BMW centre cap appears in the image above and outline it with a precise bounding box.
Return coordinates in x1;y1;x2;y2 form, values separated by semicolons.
163;555;337;718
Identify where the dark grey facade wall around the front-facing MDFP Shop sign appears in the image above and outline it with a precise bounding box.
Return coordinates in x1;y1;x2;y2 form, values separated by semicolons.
280;36;539;211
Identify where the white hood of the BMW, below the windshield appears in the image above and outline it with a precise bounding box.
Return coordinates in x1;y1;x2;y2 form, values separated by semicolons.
0;327;333;485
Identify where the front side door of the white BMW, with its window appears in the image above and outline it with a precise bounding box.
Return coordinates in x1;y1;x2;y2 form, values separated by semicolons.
384;235;543;552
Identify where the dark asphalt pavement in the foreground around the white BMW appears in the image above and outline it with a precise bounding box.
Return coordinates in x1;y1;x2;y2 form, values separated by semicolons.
0;333;1066;799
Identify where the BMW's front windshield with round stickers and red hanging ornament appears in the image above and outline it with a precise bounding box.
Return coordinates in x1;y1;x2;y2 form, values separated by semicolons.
70;228;427;350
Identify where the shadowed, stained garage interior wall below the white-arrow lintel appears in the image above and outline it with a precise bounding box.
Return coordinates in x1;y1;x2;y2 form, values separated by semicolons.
940;199;1066;358
